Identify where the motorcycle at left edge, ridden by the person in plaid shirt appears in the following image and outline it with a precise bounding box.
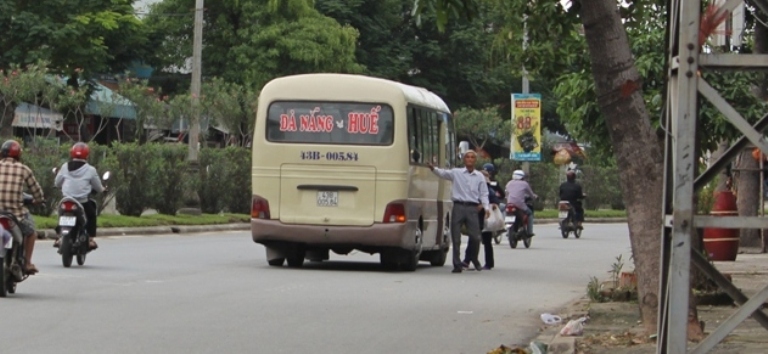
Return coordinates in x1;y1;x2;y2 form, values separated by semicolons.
0;193;32;297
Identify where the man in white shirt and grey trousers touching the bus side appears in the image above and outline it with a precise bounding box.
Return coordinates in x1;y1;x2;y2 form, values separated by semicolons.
429;150;491;273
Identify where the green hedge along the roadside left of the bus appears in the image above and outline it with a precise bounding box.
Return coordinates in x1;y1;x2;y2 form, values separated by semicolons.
23;138;251;216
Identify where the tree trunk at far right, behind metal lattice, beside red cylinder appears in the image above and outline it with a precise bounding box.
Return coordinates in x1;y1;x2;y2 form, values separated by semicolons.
735;148;763;247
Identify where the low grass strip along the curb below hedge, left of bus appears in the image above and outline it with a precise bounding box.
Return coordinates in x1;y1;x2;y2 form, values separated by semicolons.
34;214;251;230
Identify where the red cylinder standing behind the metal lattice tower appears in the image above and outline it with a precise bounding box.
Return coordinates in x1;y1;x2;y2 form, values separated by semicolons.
704;191;740;261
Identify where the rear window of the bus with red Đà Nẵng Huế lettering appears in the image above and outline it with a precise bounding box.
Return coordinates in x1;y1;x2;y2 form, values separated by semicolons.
267;101;394;145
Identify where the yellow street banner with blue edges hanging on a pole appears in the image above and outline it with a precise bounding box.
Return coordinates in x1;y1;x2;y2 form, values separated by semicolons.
509;93;541;161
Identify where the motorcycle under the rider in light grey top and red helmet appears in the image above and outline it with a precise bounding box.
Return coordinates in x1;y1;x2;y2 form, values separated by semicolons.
54;169;110;268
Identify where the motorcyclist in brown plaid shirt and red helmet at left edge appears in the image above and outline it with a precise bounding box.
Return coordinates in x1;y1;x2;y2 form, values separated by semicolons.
0;140;44;274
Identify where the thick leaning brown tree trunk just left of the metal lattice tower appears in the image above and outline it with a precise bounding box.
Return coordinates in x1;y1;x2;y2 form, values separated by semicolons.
580;0;701;337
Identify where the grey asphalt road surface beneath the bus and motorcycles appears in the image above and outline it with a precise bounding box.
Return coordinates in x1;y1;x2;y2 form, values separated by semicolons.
0;224;631;354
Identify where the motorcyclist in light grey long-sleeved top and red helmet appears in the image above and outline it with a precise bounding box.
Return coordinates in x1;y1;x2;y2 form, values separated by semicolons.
53;142;104;249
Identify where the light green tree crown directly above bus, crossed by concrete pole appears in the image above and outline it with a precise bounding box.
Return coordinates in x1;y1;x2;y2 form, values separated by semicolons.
144;0;362;89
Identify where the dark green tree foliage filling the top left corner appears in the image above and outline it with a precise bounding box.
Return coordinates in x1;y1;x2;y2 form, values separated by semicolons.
0;0;147;77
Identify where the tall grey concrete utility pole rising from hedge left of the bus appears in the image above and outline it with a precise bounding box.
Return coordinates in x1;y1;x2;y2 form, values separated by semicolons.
178;0;204;215
